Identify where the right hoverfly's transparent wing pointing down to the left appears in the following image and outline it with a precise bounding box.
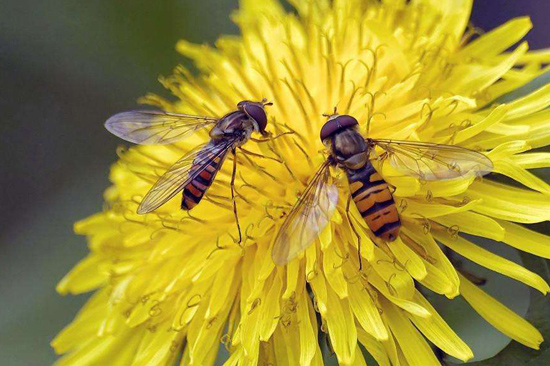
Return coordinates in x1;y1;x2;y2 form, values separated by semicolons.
271;161;338;266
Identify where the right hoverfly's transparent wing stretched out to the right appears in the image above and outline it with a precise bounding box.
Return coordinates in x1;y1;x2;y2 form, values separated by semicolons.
367;139;493;180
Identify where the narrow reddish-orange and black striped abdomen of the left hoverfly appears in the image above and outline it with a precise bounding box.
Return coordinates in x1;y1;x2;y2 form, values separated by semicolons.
181;157;223;210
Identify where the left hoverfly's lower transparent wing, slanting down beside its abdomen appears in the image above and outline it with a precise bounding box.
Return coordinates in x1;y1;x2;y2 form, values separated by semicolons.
137;139;235;215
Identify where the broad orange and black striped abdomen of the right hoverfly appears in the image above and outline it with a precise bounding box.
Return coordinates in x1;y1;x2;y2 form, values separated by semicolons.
347;162;401;241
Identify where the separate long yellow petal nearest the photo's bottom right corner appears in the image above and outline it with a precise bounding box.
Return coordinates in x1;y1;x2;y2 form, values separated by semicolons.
460;275;543;349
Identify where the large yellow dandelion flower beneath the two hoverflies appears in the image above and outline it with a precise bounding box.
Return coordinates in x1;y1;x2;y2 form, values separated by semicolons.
52;0;550;366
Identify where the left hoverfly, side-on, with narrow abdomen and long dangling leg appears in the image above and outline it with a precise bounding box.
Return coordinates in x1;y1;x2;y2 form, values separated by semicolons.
105;99;278;243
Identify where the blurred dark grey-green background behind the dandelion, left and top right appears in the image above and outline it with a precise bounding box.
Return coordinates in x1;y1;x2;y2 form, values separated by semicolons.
0;0;550;366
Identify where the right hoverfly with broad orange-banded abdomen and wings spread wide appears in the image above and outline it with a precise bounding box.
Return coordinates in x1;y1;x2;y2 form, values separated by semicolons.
272;110;493;265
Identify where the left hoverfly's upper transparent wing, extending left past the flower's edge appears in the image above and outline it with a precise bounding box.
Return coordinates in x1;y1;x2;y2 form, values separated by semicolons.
105;111;218;145
